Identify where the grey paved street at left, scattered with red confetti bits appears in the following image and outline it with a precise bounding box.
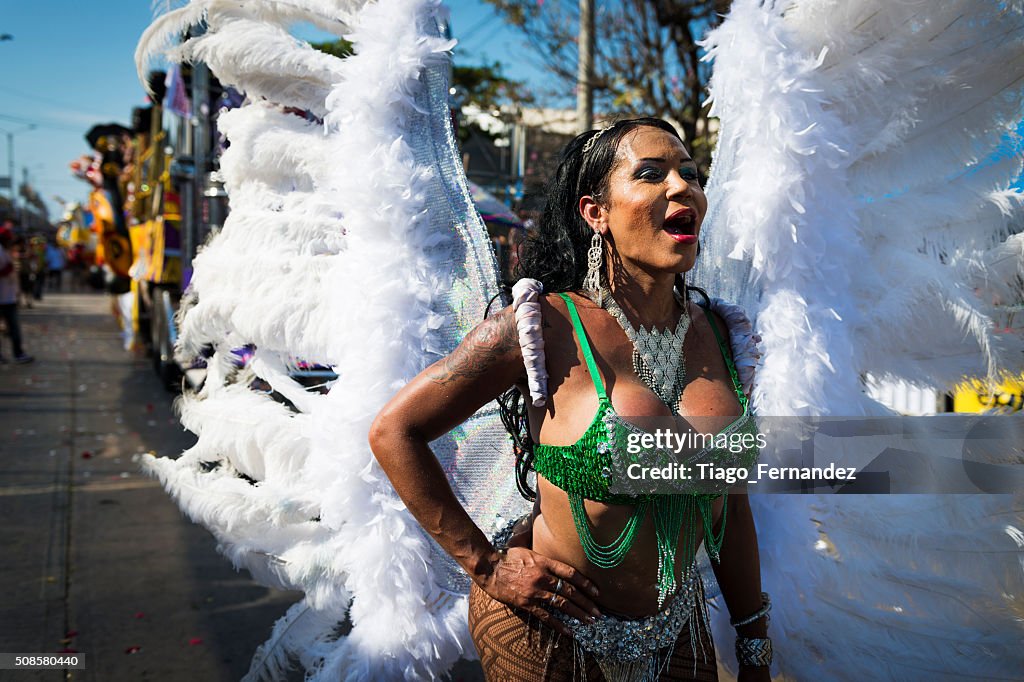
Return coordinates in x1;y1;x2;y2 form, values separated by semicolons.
0;294;300;682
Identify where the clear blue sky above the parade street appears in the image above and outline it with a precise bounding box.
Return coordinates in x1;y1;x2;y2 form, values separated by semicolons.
0;0;544;218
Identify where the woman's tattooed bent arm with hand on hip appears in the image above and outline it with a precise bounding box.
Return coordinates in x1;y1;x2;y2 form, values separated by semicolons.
370;308;597;632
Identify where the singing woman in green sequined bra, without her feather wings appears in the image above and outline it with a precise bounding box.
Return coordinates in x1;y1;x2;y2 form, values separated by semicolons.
371;119;770;680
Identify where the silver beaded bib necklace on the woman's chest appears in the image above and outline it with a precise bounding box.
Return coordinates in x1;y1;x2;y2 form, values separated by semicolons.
601;287;690;415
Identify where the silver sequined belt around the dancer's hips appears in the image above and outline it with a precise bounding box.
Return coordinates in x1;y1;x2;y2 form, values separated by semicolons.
553;563;701;663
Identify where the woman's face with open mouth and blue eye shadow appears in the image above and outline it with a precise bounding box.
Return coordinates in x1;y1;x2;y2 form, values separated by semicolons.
580;126;708;274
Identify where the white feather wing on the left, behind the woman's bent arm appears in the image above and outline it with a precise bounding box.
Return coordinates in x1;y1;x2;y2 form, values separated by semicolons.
137;0;523;680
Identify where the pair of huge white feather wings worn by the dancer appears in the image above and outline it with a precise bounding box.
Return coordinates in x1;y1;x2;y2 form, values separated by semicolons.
137;0;1024;680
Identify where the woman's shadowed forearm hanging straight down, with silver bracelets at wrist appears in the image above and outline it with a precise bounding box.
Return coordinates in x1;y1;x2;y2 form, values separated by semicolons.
712;493;771;682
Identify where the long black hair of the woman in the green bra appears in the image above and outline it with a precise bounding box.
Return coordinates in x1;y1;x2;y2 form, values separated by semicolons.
498;118;682;500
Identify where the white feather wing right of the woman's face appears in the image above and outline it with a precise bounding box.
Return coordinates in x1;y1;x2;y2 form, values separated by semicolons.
697;0;1024;680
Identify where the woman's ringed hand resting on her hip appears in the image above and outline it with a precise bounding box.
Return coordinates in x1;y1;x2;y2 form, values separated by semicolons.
480;547;600;635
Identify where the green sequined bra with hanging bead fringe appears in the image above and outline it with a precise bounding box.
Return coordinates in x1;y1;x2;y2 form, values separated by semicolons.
534;294;758;606
